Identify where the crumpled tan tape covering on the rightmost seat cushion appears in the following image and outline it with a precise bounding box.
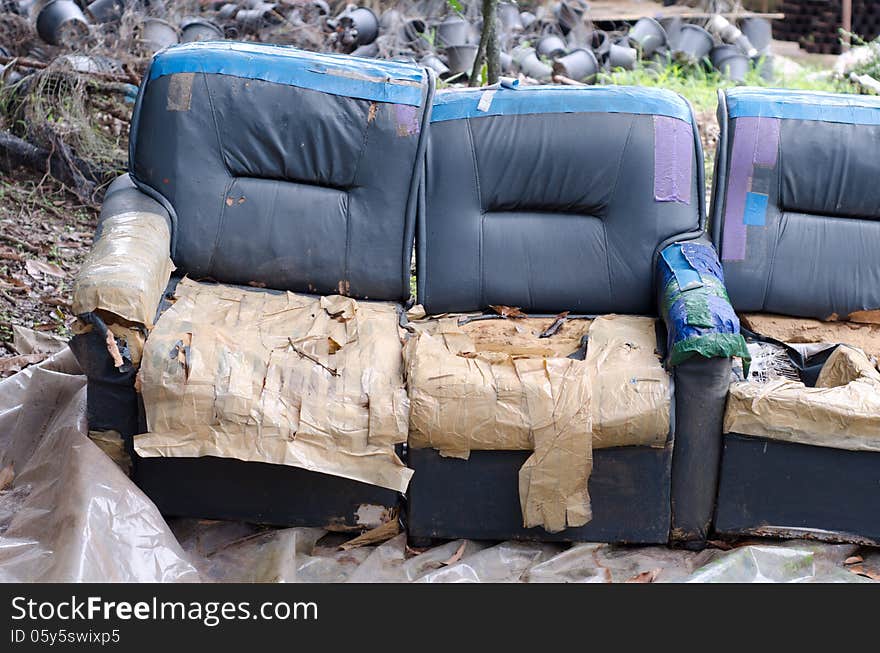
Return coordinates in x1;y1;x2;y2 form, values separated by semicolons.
724;345;880;451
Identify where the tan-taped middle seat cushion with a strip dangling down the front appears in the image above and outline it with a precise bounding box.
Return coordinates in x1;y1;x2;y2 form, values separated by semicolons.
405;315;670;532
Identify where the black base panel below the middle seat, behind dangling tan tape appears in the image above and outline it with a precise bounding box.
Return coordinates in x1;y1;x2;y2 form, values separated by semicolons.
407;445;672;544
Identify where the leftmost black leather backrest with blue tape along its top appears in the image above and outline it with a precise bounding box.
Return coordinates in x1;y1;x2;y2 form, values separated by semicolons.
131;42;432;300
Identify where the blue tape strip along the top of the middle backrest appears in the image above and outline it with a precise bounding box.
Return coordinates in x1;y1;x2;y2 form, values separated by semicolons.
431;85;692;124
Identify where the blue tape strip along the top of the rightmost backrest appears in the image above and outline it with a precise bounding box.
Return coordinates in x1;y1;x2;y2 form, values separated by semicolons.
727;87;880;125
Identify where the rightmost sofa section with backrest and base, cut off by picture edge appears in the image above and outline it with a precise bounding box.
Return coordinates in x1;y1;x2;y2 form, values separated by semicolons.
712;88;880;544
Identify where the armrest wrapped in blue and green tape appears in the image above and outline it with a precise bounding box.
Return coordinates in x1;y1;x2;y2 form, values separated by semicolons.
657;240;749;370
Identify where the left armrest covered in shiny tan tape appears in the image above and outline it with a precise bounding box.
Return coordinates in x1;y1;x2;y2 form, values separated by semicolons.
73;175;174;327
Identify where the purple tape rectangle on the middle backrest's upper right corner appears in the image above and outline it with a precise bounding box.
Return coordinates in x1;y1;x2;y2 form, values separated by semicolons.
654;116;694;204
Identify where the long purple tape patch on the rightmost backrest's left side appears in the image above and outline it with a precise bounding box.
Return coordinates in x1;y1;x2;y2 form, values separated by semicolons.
721;116;780;261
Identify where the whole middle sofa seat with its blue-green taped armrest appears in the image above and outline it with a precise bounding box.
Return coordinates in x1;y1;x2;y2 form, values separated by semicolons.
405;84;747;546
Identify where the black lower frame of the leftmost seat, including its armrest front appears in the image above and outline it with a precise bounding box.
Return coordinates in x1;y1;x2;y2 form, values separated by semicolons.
70;331;400;531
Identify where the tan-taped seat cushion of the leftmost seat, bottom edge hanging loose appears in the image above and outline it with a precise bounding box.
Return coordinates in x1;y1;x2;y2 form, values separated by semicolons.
134;279;412;492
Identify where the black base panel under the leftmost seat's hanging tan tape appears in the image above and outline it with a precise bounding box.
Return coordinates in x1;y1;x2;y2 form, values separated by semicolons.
134;456;399;530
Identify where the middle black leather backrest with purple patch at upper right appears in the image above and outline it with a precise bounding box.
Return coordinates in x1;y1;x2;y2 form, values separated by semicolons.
417;86;703;314
